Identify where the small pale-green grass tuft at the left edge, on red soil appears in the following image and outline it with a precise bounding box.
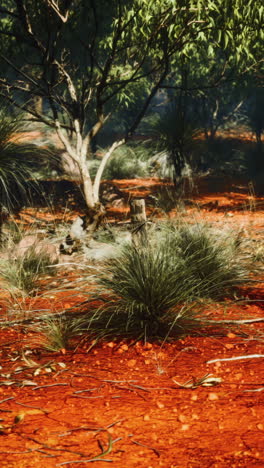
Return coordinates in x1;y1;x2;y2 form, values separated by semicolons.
0;248;54;294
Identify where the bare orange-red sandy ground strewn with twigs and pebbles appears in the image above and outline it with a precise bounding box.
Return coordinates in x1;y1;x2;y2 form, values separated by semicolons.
0;180;264;468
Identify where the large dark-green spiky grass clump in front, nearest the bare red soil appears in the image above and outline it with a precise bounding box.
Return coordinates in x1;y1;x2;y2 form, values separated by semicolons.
89;243;203;336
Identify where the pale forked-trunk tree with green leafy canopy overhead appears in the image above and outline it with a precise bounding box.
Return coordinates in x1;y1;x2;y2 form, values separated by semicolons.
0;0;263;234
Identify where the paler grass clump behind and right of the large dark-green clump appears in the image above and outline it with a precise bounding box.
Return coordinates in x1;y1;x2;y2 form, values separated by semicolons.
165;224;247;300
